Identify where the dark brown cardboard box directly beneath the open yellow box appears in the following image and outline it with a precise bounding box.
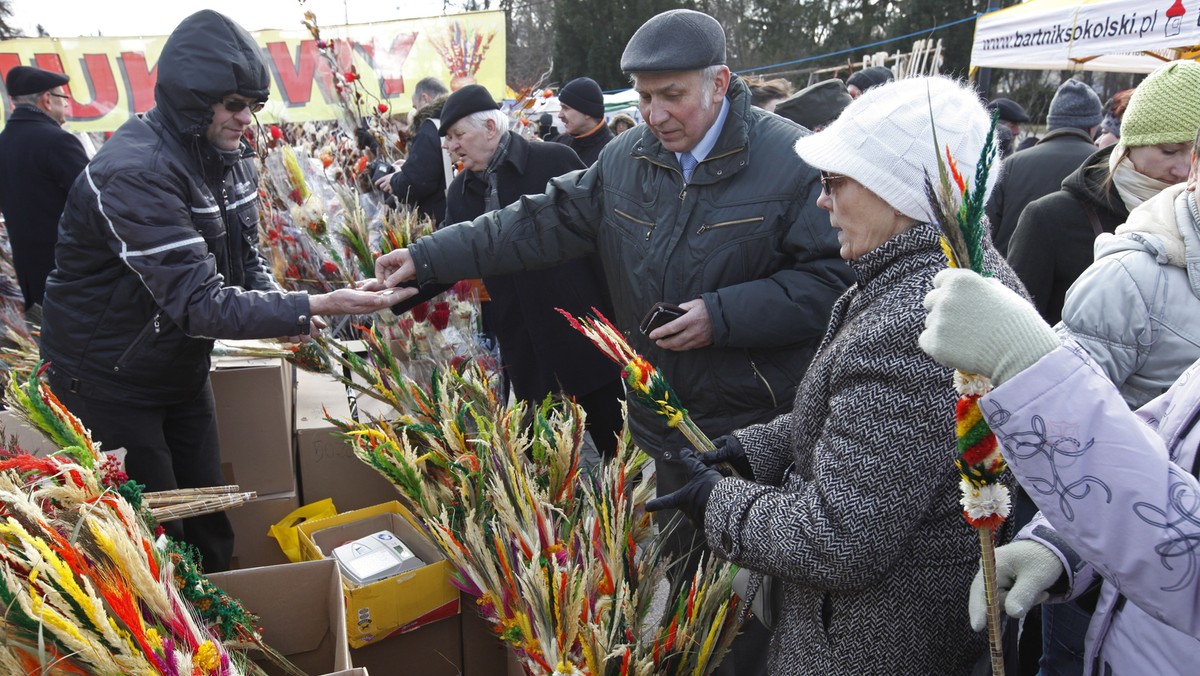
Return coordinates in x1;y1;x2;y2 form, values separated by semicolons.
350;616;472;676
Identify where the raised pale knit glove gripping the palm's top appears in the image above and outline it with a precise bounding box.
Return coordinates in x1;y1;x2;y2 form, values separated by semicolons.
918;268;1061;385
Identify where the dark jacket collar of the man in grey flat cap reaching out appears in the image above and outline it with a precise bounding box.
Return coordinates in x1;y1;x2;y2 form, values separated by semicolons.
625;76;748;185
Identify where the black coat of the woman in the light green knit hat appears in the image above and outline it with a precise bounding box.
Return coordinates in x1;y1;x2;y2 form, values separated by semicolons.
1008;145;1129;324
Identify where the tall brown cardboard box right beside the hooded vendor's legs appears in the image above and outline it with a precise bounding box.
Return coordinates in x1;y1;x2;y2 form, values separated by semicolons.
212;357;296;495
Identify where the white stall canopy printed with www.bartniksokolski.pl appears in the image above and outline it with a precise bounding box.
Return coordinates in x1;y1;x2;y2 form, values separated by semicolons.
971;0;1200;72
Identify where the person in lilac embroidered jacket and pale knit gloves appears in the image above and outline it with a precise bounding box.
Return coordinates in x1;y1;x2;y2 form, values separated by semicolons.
920;270;1200;675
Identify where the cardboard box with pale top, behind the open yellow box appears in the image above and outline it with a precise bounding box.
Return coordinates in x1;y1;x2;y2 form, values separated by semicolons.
296;371;396;512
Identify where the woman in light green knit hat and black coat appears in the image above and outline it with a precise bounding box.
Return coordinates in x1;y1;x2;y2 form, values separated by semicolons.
1001;61;1200;324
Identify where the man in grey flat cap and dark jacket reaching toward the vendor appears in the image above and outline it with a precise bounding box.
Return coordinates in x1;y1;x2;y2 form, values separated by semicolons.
376;10;853;675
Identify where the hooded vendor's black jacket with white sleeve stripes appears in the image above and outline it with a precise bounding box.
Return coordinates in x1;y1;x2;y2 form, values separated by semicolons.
41;11;310;403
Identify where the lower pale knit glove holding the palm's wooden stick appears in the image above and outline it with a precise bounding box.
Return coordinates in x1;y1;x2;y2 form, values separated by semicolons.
967;540;1062;632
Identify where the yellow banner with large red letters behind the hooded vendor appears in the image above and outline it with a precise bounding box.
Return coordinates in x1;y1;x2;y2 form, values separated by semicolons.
0;11;506;132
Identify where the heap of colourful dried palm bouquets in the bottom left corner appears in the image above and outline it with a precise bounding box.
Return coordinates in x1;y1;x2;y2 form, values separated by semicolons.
0;375;299;676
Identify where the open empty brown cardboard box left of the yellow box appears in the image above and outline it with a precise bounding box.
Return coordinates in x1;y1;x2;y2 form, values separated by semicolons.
209;561;352;674
